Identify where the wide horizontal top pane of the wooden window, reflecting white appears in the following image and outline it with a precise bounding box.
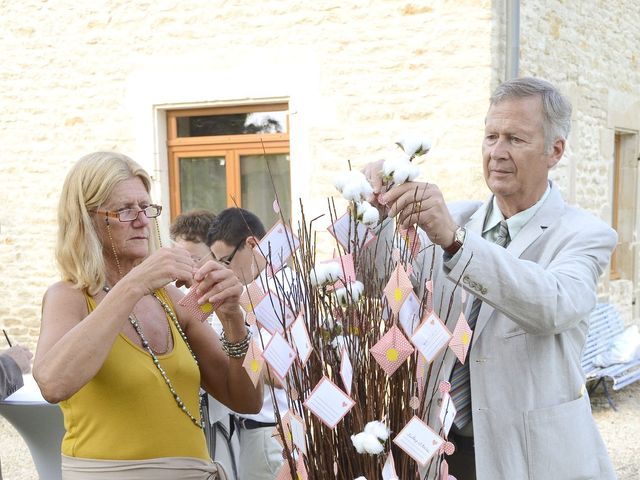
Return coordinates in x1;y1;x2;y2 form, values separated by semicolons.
177;111;287;137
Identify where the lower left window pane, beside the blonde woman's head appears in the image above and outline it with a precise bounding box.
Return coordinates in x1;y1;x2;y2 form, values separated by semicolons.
180;157;227;213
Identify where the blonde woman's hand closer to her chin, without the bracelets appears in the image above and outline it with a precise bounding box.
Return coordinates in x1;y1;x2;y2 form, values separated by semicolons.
124;247;195;295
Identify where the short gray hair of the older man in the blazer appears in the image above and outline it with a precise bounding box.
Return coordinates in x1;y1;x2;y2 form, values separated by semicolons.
490;77;571;153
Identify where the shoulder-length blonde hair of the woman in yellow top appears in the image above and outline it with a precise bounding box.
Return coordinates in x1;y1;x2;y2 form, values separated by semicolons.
56;152;158;295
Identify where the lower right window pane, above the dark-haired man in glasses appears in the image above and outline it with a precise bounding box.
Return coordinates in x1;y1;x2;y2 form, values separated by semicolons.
240;153;291;230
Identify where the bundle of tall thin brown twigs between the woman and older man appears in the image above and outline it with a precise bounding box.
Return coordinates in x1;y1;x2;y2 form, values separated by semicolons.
248;136;468;480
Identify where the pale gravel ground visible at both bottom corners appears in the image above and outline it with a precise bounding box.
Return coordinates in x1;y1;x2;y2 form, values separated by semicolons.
0;382;640;480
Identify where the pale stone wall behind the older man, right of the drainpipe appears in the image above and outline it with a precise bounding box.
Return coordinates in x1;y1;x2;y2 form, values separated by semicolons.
516;0;640;322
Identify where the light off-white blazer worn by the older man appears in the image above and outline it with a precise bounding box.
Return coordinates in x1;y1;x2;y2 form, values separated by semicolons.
398;184;617;480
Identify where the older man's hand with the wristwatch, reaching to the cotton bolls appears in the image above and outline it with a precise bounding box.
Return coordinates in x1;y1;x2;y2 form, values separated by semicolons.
378;182;458;248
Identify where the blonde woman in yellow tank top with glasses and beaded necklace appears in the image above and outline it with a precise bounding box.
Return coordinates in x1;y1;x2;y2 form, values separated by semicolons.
33;152;262;480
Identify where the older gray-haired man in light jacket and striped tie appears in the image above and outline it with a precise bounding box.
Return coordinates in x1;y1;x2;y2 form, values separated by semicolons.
365;78;617;480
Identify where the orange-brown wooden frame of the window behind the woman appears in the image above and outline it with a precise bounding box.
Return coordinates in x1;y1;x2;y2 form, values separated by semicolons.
167;103;290;221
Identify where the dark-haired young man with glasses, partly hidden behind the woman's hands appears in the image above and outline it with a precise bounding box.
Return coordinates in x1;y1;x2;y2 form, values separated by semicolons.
207;208;293;480
